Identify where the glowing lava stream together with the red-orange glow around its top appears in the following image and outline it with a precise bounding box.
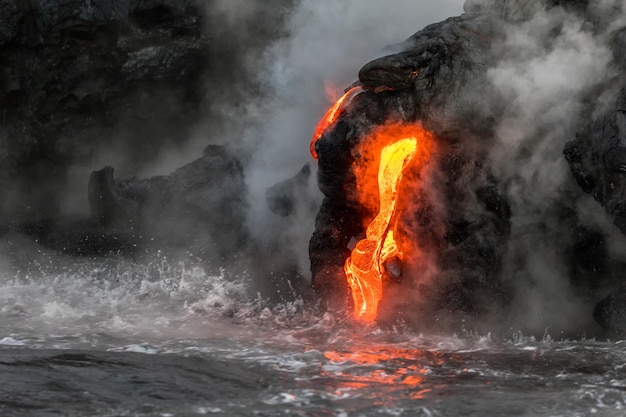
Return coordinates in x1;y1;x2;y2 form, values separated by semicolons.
344;125;431;323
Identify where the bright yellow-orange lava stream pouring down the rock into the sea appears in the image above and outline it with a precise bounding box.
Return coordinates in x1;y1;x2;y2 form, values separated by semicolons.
344;136;418;322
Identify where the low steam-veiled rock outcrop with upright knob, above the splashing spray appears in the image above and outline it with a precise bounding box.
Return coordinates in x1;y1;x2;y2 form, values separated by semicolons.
89;145;247;258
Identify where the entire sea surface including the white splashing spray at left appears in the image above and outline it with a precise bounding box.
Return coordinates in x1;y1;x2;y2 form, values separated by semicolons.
0;250;626;417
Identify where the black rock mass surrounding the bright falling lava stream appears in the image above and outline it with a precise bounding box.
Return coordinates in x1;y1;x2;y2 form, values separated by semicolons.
310;15;510;328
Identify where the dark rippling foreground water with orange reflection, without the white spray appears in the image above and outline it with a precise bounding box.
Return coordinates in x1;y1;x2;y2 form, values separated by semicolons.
0;325;626;416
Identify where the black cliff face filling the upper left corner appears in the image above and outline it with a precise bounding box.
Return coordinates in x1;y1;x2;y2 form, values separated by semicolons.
0;0;211;222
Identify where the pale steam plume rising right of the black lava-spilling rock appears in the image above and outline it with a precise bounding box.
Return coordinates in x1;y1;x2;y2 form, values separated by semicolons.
488;2;623;331
